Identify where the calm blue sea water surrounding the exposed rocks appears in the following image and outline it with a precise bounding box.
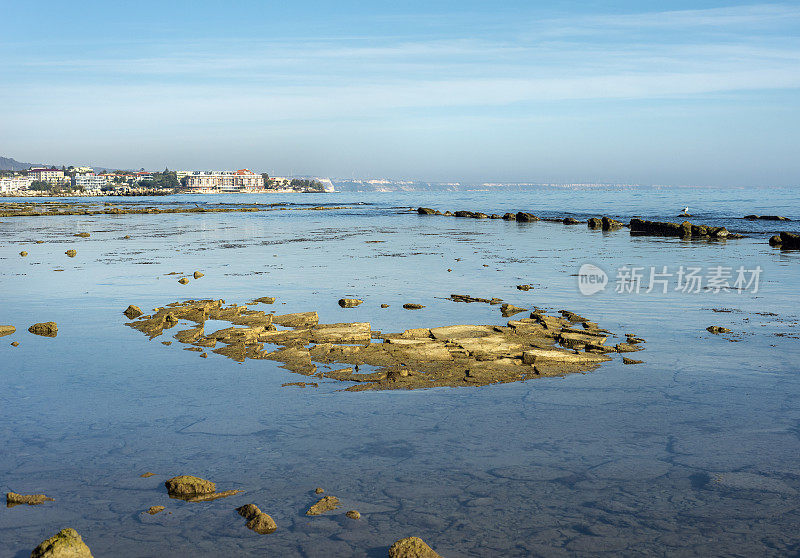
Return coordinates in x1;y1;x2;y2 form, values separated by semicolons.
0;188;800;557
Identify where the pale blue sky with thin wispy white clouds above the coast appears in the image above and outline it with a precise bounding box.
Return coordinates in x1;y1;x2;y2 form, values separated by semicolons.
0;0;800;186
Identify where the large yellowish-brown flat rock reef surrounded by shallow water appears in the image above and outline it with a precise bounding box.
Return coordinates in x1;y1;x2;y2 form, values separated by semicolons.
122;295;644;394
